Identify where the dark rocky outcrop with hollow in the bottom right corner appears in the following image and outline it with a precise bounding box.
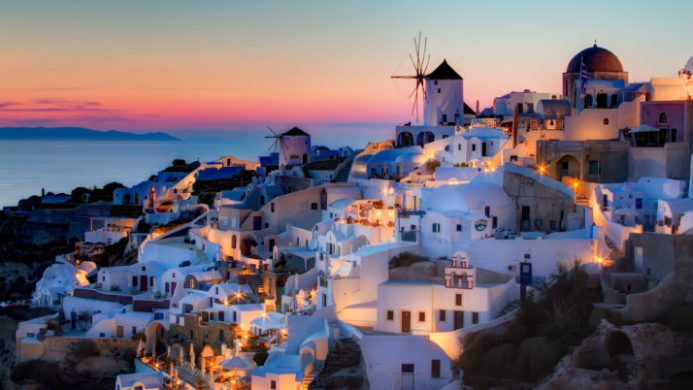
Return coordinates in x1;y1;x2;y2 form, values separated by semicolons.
539;320;693;389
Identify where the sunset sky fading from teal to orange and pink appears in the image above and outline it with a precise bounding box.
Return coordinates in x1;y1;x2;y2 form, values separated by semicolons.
0;0;693;138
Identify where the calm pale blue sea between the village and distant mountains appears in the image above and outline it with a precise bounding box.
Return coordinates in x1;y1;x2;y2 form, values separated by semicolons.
0;128;384;207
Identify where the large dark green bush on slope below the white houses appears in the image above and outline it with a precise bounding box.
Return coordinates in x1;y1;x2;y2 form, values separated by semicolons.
459;264;599;382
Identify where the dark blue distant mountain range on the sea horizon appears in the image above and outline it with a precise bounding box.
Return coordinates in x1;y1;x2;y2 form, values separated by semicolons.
0;127;180;141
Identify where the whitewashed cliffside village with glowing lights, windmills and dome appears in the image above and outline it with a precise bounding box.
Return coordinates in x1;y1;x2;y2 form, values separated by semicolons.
10;44;693;390
